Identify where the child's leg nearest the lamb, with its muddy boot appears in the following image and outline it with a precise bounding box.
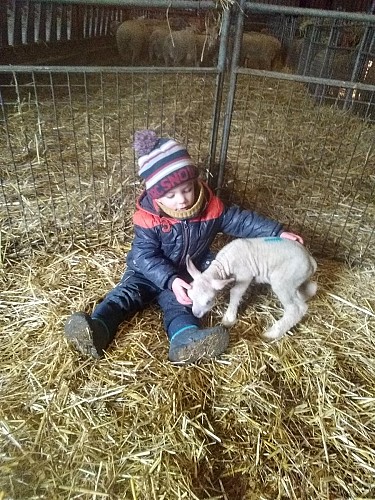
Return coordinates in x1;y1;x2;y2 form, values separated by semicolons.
157;290;229;363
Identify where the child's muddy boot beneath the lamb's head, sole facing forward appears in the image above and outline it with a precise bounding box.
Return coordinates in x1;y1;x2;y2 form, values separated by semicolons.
168;326;229;363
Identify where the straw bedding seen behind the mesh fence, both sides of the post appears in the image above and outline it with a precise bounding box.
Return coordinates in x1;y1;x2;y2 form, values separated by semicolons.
0;74;375;264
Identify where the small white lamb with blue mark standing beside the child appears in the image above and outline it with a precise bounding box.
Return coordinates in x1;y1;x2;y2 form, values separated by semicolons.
186;237;317;340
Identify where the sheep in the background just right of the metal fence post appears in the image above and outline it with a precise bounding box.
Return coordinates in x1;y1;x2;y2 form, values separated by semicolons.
240;31;285;71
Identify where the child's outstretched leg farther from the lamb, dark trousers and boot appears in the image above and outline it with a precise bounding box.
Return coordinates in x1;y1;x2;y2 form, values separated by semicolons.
65;270;159;358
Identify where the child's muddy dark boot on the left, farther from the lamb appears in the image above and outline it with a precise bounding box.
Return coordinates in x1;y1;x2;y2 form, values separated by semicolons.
64;312;109;358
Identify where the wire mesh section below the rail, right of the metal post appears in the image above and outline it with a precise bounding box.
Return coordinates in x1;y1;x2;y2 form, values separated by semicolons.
223;75;375;260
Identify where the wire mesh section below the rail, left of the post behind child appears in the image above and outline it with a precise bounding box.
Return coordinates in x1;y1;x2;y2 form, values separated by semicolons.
1;67;219;255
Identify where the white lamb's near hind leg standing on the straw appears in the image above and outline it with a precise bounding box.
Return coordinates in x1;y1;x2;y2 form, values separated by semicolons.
263;283;307;340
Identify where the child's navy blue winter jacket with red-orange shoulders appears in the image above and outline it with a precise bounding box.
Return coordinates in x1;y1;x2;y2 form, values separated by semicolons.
127;185;283;290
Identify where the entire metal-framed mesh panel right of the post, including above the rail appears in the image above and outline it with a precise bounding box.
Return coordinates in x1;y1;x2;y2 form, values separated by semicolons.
219;2;375;262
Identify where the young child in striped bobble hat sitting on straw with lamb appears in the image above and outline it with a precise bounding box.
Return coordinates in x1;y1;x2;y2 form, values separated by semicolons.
65;130;303;363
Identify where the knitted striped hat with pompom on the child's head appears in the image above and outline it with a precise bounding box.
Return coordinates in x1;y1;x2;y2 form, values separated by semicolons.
133;130;198;199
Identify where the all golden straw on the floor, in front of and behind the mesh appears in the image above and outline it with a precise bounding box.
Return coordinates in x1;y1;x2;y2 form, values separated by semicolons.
0;71;375;500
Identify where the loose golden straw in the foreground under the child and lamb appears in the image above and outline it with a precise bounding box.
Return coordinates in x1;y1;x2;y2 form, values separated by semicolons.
0;246;375;500
